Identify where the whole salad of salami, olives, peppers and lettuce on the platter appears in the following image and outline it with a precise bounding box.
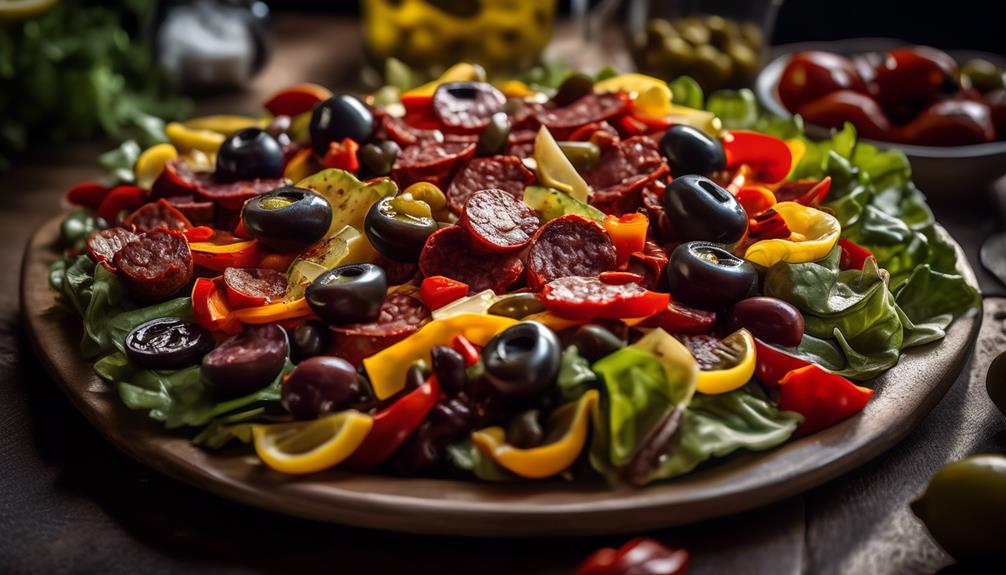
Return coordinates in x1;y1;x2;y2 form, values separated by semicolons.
50;63;979;486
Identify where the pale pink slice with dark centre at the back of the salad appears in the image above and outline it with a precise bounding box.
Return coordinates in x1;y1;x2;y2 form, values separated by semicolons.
434;81;506;134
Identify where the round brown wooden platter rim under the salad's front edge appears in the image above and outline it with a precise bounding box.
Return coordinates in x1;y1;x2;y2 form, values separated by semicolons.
21;216;981;537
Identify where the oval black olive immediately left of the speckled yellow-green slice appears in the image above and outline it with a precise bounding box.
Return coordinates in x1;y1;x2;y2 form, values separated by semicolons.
241;186;332;252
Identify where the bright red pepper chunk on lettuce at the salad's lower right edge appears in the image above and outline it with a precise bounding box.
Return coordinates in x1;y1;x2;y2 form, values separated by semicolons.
779;364;873;434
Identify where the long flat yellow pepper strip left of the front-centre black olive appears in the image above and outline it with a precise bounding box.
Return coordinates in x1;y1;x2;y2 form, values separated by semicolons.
363;314;517;399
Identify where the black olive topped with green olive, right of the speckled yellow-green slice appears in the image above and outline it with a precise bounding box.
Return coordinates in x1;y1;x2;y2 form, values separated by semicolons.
363;198;439;261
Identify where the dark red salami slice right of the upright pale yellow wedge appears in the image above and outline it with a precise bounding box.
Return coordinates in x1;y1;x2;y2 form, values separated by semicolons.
583;136;670;205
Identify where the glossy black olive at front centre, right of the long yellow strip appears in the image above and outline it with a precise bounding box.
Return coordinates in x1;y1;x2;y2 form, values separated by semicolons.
482;322;560;397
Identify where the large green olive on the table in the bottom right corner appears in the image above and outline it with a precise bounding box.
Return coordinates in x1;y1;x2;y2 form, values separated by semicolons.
911;454;1006;560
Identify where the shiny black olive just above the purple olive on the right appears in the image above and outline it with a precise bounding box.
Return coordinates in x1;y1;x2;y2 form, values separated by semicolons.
667;241;758;310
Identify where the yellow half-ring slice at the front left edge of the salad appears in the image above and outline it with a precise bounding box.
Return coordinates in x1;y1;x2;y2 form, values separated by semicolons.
252;410;373;474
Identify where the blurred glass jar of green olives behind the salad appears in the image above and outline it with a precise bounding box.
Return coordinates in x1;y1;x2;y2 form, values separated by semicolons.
627;0;783;91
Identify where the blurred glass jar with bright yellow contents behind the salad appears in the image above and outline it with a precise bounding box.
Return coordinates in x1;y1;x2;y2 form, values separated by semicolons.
360;0;555;74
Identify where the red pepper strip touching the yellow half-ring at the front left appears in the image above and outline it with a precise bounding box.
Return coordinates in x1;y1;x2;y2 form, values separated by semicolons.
345;375;440;469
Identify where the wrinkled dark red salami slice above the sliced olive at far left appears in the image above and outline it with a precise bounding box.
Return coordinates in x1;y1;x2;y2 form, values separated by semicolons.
112;227;192;302
